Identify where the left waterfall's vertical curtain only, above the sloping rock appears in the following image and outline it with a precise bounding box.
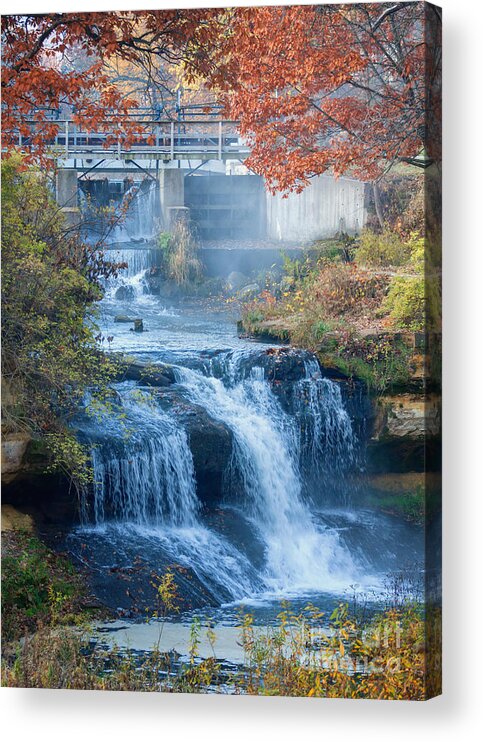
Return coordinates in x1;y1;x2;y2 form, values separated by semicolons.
82;389;198;526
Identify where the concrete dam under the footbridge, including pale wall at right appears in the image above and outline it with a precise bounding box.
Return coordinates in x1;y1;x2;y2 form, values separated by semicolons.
57;167;366;246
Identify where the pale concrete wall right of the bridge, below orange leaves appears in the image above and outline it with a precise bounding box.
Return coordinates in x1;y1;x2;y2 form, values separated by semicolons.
266;175;366;242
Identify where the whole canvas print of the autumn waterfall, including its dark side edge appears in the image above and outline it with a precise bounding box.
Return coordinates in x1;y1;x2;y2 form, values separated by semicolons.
2;2;441;700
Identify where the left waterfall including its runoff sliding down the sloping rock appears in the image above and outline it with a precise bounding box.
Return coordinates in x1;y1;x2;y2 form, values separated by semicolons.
78;383;261;603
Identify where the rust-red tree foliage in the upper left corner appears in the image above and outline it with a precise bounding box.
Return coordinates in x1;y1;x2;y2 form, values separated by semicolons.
2;10;224;159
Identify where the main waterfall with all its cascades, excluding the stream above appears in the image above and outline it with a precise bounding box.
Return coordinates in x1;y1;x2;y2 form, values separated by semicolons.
76;349;378;602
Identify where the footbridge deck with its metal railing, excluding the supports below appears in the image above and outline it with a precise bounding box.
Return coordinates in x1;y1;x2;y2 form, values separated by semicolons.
18;117;250;164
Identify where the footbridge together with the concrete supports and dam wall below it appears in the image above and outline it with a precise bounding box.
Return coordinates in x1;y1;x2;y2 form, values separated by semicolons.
18;112;366;242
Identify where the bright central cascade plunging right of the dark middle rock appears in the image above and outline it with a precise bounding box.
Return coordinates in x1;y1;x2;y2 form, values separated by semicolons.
176;356;356;593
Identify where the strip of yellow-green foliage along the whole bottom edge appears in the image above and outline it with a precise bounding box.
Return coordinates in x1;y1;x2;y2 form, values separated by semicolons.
3;604;441;700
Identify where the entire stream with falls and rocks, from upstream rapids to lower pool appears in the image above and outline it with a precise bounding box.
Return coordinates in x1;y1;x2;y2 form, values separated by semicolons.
66;244;423;662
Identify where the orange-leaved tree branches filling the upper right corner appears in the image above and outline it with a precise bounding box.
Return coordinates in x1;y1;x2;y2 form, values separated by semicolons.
199;2;441;190
